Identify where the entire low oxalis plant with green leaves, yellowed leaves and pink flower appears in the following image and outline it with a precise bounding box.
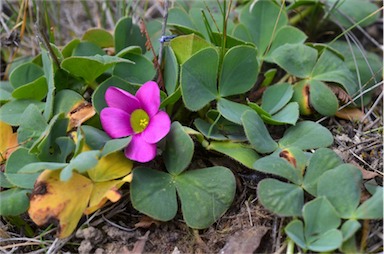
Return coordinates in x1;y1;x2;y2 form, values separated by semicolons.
0;0;383;252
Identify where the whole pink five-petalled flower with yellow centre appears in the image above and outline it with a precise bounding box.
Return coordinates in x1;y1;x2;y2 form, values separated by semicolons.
100;81;171;162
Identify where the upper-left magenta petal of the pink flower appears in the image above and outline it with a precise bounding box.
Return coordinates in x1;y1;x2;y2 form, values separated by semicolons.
105;86;141;114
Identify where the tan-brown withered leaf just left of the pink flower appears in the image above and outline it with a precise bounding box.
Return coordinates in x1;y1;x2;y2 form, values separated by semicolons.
68;101;96;130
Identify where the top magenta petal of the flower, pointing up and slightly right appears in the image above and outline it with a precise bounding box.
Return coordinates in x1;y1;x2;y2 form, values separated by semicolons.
136;81;160;117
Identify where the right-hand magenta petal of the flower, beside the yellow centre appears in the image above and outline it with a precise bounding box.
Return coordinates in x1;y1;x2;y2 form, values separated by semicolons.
142;111;171;144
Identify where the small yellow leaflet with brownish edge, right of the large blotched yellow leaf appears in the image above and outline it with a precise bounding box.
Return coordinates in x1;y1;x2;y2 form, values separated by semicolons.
84;180;124;214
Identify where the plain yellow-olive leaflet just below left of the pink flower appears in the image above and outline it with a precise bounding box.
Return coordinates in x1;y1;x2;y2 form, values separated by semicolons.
88;152;133;182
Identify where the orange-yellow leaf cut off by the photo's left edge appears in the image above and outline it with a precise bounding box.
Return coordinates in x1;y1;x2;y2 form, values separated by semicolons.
0;121;18;162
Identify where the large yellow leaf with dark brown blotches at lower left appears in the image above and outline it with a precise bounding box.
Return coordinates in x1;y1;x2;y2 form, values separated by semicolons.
28;170;93;238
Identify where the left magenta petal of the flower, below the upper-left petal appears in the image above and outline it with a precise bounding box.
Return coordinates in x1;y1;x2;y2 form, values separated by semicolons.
100;108;134;138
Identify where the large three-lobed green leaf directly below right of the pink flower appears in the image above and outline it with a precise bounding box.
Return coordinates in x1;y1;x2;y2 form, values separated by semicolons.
131;122;236;228
